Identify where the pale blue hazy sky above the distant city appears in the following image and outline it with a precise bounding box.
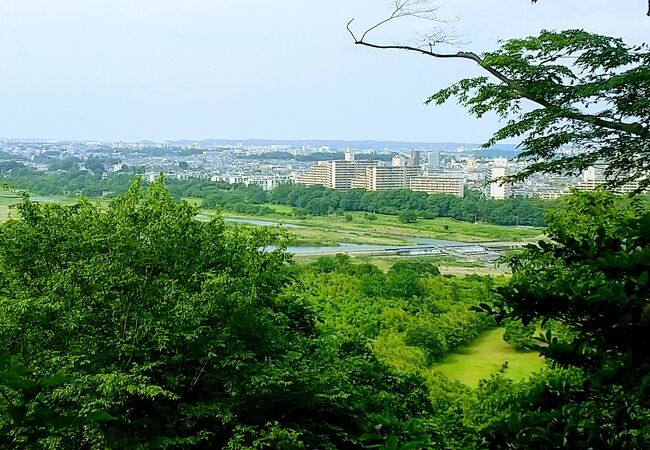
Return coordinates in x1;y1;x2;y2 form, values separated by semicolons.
0;0;650;143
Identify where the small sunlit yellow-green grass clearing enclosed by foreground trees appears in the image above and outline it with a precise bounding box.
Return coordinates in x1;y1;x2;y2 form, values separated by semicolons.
431;328;544;387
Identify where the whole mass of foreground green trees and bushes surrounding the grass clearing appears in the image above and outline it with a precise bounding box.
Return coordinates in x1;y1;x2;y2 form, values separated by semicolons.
0;180;650;449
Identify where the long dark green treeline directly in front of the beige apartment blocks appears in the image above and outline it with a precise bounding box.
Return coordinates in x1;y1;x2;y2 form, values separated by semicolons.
168;179;556;227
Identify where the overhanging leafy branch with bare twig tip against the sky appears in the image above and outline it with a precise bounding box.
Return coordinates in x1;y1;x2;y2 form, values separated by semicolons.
348;0;650;189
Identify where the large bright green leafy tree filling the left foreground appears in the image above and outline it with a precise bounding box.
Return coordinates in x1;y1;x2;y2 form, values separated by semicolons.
0;180;438;449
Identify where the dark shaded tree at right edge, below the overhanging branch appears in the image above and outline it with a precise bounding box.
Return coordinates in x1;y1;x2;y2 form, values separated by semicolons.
470;192;650;448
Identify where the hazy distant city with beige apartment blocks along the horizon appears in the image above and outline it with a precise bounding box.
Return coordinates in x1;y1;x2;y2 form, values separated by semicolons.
0;139;637;199
